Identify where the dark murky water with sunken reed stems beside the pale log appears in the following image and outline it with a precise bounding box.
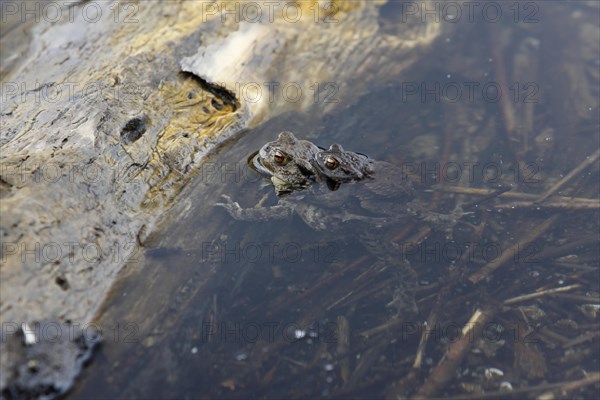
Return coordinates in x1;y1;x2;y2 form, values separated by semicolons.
70;2;600;398
